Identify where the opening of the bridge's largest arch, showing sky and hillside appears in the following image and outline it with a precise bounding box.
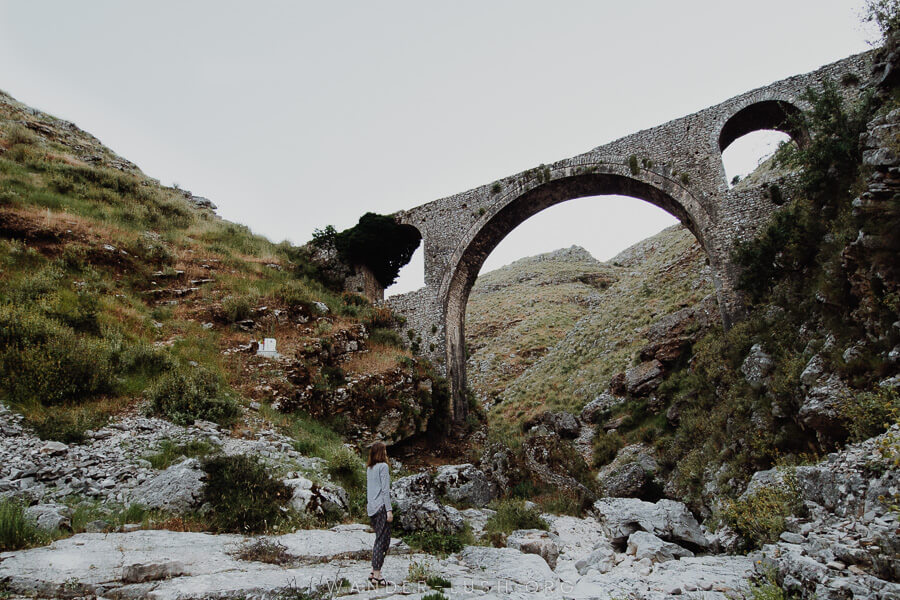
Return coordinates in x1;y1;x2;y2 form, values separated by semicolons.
465;196;684;412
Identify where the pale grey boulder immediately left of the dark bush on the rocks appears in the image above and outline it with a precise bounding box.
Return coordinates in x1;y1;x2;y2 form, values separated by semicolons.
131;458;206;513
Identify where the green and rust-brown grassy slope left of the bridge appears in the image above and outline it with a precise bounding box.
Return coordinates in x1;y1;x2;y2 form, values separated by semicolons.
0;86;408;454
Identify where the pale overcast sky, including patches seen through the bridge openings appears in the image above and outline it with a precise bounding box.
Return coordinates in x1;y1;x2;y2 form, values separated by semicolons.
0;0;876;293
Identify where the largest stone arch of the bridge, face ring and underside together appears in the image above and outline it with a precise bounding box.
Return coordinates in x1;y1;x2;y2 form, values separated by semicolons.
439;162;721;420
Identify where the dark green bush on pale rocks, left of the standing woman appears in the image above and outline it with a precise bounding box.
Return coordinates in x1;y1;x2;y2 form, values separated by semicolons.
203;455;292;533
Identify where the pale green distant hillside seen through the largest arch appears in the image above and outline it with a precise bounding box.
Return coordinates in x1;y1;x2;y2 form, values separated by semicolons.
466;226;713;431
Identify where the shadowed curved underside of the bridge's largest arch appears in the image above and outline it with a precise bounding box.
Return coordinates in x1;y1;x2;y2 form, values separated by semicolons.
443;173;704;420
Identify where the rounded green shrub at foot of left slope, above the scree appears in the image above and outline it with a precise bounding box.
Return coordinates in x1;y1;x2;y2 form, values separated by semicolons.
146;367;240;426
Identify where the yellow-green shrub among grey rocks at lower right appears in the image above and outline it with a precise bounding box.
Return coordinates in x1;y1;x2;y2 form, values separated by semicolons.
718;473;802;549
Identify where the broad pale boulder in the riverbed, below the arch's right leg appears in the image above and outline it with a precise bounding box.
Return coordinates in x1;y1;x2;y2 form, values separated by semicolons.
594;498;709;549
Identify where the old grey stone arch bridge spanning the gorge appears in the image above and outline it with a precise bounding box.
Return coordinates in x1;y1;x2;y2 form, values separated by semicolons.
387;53;871;421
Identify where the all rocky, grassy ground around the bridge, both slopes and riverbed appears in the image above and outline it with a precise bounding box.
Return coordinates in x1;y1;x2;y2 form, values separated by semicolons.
0;15;900;600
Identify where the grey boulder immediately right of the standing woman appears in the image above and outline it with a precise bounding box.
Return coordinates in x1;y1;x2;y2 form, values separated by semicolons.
391;473;465;533
